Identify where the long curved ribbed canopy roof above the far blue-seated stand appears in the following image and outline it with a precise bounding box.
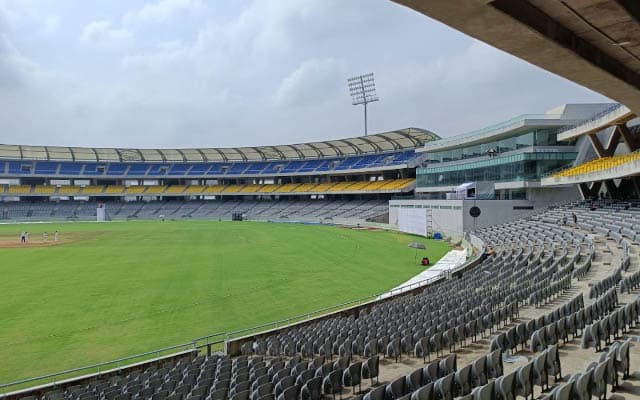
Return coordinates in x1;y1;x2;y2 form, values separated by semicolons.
0;128;440;162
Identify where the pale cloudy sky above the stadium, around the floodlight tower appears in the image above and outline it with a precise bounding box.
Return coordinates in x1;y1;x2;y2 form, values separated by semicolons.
0;0;606;147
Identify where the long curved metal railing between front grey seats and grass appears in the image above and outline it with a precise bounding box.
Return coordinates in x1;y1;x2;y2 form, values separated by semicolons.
0;242;481;398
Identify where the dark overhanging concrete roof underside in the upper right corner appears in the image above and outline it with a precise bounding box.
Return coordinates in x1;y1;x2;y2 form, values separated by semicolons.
393;0;640;114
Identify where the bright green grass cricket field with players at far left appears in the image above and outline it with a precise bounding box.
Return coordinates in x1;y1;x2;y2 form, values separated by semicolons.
0;221;449;382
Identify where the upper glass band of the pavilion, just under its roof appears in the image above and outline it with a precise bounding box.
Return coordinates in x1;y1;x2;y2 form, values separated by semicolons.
426;128;572;164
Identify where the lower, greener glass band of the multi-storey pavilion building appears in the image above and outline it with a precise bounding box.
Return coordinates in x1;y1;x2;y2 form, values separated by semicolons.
417;152;577;187
